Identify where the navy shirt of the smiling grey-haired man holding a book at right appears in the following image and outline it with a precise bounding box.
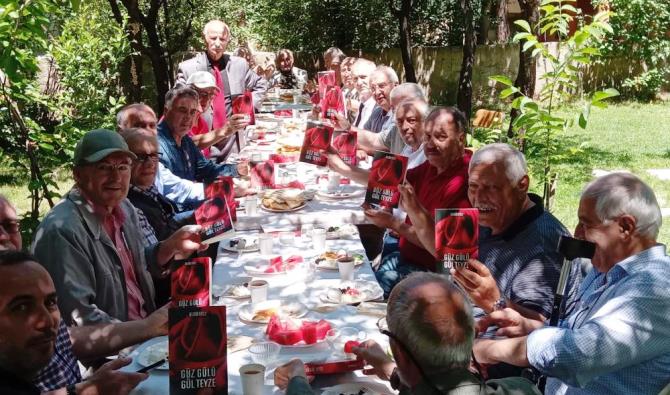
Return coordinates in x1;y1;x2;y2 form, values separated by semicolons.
475;194;581;318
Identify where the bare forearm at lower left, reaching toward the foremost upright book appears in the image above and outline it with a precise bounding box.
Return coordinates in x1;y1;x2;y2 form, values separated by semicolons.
68;320;157;360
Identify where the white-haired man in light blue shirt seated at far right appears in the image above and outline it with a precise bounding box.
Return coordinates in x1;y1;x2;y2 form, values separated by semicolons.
475;173;670;394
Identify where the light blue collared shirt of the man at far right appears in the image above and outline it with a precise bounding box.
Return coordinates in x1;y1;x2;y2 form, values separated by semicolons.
527;244;670;395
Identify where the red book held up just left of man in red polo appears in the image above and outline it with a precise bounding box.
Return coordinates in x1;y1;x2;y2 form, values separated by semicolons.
365;151;407;209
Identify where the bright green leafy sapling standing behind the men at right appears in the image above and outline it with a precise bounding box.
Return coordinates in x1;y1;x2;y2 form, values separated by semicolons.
490;0;619;208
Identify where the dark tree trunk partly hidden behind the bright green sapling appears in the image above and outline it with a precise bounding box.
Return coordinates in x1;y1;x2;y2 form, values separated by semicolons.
507;0;540;140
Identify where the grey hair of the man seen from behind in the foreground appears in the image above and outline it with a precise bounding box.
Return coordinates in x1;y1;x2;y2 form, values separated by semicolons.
387;272;475;373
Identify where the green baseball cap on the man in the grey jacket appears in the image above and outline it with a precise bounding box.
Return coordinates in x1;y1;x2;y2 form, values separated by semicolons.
74;129;137;166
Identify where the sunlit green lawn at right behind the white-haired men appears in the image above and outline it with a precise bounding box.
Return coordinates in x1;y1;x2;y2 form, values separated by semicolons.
532;102;670;244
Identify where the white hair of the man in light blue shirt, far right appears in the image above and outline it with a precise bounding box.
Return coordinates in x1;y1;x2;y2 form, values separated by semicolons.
582;172;663;240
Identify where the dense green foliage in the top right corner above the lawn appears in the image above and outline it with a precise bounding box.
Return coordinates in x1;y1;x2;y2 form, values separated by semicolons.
593;0;670;101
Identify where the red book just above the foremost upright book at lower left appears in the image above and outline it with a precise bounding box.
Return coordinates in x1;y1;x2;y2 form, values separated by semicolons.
170;257;212;307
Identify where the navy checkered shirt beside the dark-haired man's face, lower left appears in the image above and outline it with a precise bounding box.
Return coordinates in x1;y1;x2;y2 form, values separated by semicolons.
33;320;81;391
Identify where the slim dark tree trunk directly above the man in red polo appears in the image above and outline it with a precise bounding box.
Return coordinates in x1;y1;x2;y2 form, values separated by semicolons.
457;0;477;119
